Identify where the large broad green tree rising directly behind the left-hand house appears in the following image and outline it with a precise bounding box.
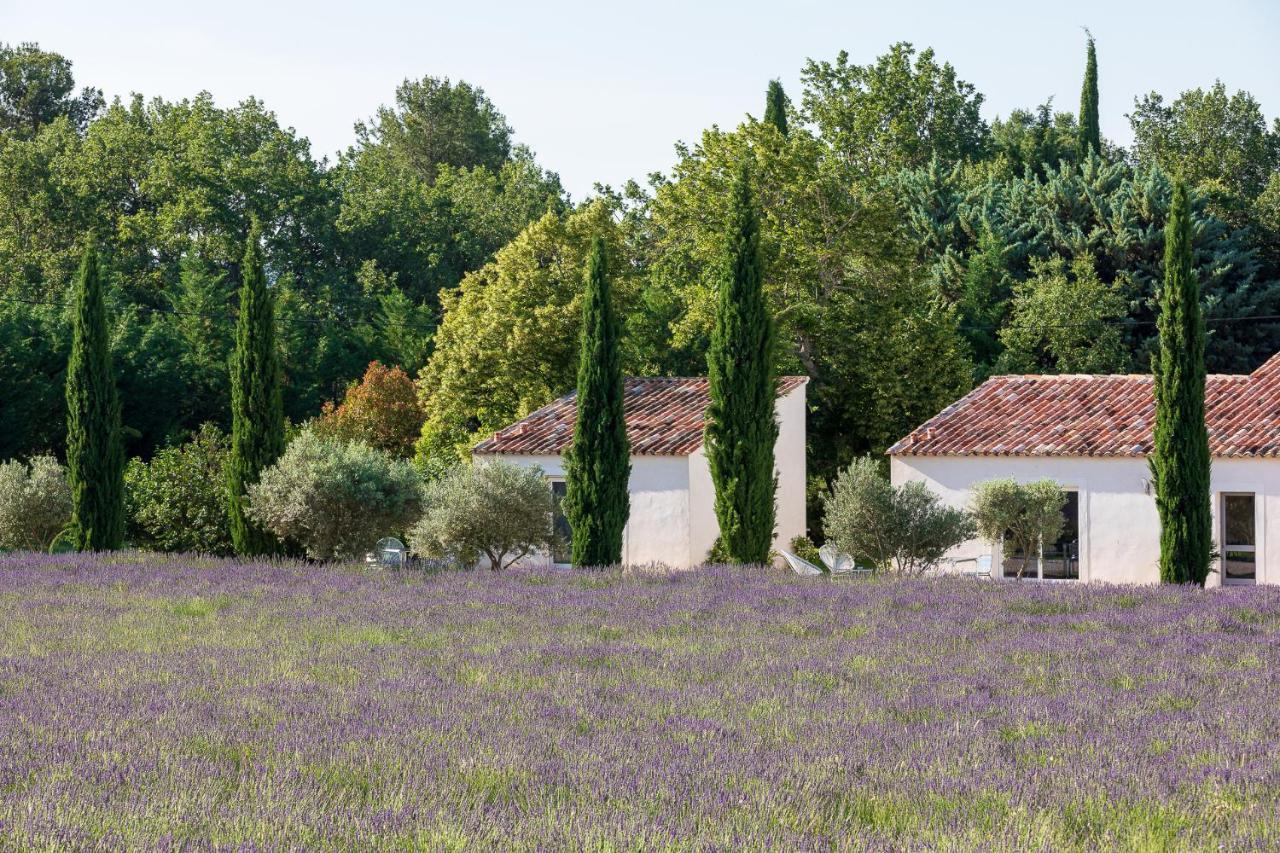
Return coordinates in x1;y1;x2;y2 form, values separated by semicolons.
650;122;972;484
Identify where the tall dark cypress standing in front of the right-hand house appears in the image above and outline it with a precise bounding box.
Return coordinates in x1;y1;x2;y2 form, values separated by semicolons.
1151;181;1213;587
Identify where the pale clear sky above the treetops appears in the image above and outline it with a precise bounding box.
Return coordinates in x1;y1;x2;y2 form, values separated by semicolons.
0;0;1280;199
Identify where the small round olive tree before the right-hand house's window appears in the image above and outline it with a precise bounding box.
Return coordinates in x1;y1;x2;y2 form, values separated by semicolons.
973;479;1066;578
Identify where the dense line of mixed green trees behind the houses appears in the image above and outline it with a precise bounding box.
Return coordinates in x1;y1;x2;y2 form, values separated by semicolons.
0;37;1280;532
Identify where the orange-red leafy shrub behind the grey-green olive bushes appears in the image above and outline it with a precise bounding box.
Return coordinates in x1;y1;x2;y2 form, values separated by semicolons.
315;361;426;457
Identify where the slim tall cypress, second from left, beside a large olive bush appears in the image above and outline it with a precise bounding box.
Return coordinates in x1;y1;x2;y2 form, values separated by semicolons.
228;223;284;555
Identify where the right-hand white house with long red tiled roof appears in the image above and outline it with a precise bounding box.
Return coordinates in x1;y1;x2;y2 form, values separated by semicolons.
888;355;1280;585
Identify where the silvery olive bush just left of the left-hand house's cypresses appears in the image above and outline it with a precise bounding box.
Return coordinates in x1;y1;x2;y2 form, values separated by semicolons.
410;460;554;570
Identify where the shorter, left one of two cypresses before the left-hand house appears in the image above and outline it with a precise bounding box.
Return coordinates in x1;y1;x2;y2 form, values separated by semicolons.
563;237;631;566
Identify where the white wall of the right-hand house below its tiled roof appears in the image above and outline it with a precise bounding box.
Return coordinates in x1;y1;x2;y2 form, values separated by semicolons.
890;456;1280;585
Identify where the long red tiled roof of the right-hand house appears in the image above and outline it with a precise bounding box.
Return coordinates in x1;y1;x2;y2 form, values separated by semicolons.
888;355;1280;457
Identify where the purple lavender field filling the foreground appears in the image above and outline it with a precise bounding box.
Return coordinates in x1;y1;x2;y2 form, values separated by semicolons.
0;555;1280;849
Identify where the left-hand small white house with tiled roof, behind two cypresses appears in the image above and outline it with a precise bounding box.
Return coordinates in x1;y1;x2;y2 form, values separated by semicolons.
472;377;808;569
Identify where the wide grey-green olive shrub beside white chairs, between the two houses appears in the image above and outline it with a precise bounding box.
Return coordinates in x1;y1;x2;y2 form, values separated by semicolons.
823;457;975;574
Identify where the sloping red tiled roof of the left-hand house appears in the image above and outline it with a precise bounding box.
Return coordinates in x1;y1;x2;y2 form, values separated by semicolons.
472;377;808;456
